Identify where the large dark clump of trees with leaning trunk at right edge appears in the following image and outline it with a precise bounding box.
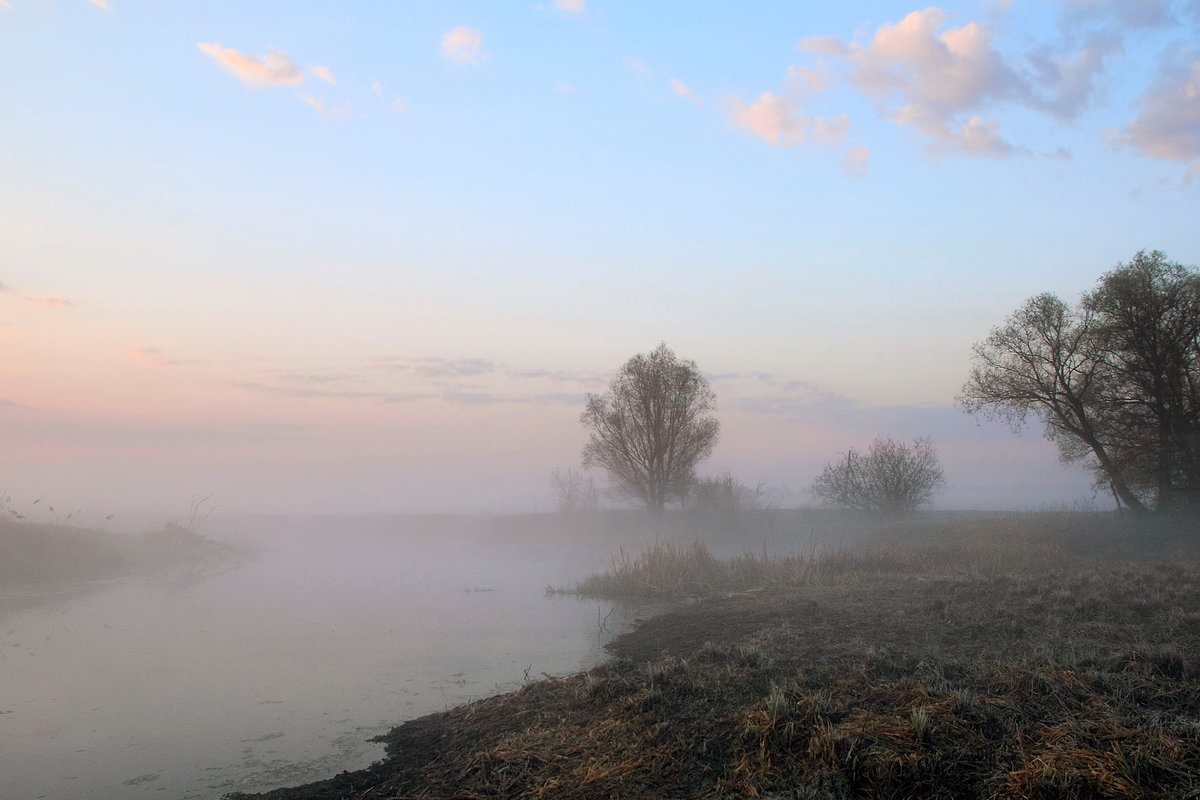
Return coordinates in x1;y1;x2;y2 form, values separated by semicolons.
959;251;1200;512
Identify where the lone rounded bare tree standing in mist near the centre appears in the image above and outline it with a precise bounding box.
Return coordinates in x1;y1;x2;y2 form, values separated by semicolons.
580;343;721;512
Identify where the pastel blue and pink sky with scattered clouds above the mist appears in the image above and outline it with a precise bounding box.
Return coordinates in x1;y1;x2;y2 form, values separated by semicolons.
0;0;1200;522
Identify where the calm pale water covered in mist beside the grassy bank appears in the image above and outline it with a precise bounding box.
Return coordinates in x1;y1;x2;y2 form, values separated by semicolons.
0;518;662;800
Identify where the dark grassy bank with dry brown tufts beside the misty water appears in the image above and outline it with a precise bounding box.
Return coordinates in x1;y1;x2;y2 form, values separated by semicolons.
234;515;1200;800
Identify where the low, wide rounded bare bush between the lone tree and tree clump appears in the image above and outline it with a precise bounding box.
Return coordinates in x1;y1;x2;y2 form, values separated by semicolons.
812;438;946;513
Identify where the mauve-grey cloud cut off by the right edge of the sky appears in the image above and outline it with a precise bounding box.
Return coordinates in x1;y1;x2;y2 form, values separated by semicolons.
1118;59;1200;163
